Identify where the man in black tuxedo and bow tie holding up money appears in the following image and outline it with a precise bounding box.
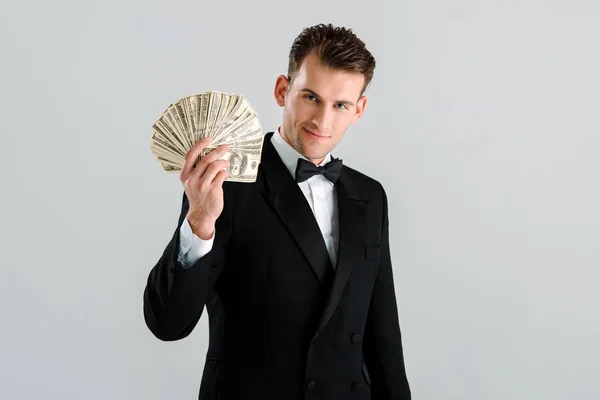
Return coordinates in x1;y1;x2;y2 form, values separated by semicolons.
144;25;411;400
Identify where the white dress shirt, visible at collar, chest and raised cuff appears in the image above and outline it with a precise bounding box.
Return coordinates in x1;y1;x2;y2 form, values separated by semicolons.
179;130;339;268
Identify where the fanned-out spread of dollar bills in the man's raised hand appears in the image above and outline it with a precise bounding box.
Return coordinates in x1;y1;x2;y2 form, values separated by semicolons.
151;91;263;182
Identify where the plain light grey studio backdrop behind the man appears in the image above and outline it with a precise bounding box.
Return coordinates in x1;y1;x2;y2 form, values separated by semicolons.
0;0;600;400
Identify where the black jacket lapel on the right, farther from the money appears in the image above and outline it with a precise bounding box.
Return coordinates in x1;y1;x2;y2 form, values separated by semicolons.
315;166;366;335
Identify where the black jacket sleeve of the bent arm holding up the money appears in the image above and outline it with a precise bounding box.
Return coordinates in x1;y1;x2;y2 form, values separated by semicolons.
143;193;229;341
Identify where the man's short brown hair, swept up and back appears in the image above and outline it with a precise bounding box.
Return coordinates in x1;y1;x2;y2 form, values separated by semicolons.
288;24;375;95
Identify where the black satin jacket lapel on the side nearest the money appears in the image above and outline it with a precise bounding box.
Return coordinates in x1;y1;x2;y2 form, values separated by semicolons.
259;132;332;283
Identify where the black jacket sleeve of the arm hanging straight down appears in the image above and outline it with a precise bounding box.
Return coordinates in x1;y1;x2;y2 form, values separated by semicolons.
363;187;411;400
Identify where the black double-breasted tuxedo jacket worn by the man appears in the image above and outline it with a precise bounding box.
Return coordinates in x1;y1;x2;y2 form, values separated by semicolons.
144;132;411;400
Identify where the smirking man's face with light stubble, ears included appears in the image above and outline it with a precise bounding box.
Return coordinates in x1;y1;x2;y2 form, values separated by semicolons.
275;54;367;164
